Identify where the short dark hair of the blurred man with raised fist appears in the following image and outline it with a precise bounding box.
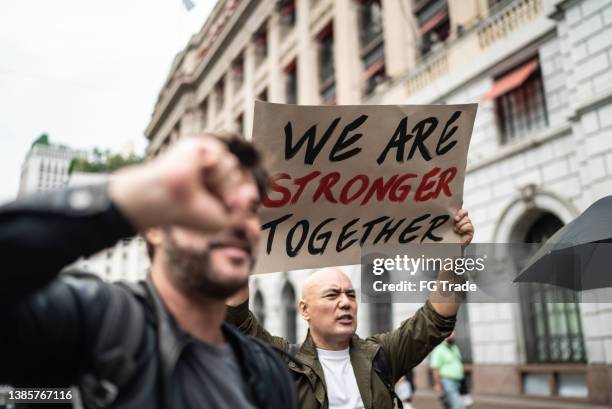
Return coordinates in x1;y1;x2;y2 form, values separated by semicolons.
143;132;269;260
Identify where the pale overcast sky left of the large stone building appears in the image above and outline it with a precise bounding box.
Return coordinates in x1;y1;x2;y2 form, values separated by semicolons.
0;0;216;202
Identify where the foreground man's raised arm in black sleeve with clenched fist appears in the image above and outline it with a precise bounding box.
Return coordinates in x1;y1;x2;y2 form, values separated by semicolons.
0;138;249;304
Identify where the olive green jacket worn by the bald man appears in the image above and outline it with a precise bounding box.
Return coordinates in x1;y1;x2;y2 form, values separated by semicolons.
226;301;455;409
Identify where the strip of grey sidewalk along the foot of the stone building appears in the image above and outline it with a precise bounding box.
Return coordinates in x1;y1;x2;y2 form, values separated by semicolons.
404;391;610;409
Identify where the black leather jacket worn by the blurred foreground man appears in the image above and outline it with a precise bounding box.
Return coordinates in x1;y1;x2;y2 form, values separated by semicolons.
0;186;297;408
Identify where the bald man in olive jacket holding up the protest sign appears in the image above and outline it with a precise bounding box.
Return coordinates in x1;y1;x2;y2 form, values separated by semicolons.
226;209;474;409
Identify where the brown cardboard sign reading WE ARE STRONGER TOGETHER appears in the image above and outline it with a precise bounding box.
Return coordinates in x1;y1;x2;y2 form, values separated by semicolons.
253;101;477;273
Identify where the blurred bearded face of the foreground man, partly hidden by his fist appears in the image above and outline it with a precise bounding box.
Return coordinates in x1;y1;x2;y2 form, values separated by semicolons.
162;173;261;299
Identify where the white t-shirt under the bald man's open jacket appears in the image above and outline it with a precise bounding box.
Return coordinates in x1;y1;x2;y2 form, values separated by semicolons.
317;348;363;409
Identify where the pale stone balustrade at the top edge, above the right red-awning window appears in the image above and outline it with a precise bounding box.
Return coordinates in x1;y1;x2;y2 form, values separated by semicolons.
478;0;542;48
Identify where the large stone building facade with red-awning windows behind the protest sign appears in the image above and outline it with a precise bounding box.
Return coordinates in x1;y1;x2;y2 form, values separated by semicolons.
146;0;612;404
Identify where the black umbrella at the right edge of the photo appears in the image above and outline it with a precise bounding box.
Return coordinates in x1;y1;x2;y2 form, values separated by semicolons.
514;196;612;290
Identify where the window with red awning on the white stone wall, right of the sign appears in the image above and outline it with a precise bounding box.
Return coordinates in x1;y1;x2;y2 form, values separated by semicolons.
483;59;548;143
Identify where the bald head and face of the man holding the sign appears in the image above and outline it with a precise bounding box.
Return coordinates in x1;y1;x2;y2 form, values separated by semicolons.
302;269;357;343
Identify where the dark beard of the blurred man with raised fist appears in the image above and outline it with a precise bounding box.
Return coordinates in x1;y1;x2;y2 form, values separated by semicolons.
164;234;249;299
